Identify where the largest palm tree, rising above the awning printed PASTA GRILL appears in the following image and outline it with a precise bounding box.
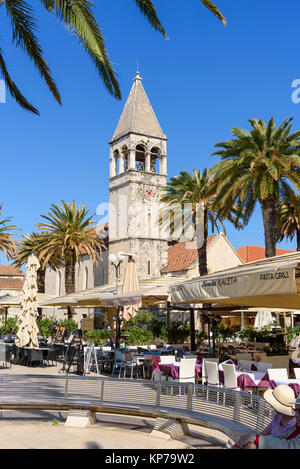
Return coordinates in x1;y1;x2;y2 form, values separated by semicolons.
210;118;300;257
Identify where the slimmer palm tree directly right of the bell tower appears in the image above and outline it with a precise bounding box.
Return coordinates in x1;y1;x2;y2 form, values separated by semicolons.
161;169;238;275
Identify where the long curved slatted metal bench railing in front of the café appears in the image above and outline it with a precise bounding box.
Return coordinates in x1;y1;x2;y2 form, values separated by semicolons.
0;374;273;439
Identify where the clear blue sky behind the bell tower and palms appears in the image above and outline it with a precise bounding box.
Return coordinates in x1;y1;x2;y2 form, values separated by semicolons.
0;0;300;262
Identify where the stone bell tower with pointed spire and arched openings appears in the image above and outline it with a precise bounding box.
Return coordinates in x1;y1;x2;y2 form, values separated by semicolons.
109;72;168;282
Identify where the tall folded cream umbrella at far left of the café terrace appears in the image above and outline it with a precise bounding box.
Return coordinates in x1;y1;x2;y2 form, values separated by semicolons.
15;255;40;347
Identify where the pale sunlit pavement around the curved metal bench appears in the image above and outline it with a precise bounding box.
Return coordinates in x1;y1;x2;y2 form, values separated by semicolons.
0;364;227;449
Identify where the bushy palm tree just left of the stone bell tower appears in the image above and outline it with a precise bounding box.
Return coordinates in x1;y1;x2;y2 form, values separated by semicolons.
36;201;105;318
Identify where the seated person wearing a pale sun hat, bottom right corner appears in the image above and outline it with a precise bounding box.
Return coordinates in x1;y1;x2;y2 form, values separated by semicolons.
233;384;300;449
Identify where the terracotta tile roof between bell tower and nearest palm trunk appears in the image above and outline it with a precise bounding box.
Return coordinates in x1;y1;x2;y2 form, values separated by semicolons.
161;236;216;273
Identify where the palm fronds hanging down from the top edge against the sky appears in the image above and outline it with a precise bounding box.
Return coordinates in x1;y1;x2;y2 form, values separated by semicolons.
0;0;226;114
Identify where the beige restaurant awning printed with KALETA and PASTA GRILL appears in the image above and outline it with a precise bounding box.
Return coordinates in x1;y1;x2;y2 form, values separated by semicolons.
169;253;300;309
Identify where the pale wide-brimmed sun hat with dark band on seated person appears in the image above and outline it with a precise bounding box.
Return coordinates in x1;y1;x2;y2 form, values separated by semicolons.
264;384;296;417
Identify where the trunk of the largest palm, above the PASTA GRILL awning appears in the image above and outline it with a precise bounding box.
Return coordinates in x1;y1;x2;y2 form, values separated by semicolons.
261;199;277;257
